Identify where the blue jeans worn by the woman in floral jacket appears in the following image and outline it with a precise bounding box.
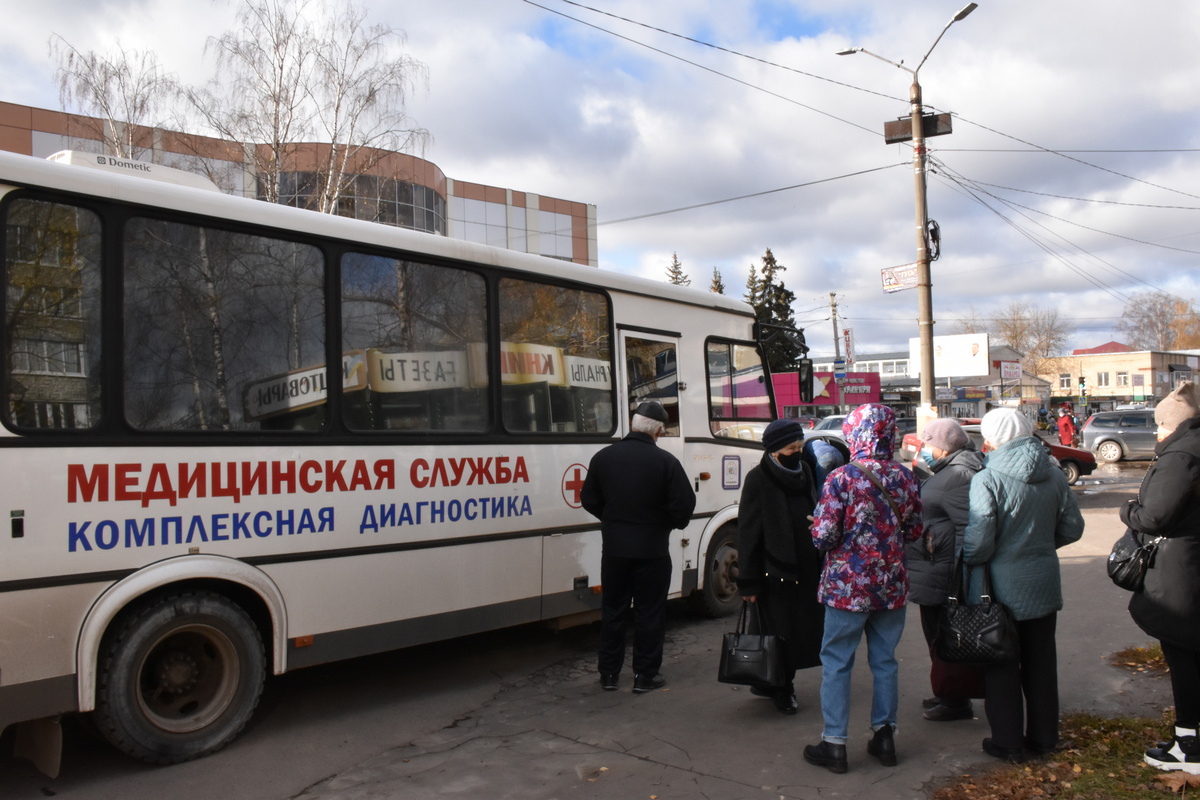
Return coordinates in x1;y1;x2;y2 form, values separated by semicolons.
821;606;905;745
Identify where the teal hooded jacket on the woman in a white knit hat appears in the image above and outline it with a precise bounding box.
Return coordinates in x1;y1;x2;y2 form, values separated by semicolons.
962;437;1084;620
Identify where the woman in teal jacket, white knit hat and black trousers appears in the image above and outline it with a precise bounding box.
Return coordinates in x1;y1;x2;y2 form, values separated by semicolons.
962;408;1084;763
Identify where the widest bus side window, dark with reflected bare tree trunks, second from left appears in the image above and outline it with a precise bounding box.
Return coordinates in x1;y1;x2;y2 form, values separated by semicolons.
125;218;325;431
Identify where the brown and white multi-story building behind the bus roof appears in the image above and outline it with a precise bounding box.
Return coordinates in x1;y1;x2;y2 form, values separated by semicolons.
0;102;599;266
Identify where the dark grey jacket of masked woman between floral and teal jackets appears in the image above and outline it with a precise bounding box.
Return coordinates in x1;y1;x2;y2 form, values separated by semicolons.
905;449;983;606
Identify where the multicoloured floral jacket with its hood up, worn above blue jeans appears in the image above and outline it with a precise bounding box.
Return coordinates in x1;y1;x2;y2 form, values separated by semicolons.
812;403;923;612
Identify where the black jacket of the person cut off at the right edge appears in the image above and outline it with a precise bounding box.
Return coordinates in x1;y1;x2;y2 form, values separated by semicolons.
1121;416;1200;652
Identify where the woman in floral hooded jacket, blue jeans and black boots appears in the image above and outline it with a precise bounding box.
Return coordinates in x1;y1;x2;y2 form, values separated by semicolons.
804;403;923;772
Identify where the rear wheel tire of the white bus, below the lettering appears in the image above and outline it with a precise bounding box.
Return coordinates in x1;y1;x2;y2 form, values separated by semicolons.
95;591;266;764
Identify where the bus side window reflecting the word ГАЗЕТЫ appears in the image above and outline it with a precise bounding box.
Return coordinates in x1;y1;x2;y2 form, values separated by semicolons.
342;253;491;431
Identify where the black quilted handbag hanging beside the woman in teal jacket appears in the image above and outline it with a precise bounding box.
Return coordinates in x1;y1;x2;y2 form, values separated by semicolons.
934;561;1021;667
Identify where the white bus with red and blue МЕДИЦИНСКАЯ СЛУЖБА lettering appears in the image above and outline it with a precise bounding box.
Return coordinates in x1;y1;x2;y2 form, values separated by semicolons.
0;148;806;769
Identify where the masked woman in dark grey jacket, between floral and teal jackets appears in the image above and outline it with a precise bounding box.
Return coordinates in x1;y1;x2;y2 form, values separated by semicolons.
905;419;983;722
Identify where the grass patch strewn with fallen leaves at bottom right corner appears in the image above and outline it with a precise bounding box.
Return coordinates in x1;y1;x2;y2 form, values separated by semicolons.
931;714;1180;800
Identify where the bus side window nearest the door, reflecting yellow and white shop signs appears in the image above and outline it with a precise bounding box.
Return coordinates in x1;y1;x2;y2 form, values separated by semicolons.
499;278;613;433
